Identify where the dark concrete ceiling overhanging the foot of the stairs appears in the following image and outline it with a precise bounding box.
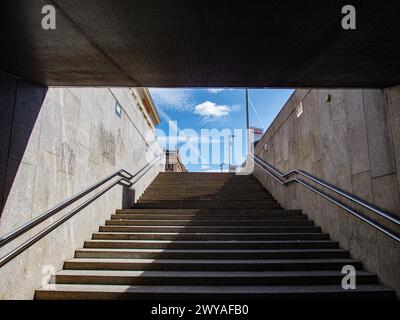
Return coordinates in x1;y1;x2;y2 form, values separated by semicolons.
0;0;400;87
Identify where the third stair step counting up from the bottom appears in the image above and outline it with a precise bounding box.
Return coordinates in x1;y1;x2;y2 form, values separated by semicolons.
64;258;361;271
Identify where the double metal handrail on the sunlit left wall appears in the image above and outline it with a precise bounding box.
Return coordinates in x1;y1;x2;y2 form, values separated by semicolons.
0;155;162;268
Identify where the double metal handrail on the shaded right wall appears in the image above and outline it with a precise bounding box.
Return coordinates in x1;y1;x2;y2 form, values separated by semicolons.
249;154;400;242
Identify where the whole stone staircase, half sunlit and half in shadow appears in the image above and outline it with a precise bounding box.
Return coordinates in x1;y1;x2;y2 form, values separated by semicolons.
36;173;395;299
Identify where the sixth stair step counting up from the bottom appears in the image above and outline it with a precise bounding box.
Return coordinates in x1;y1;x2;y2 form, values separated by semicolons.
93;232;329;241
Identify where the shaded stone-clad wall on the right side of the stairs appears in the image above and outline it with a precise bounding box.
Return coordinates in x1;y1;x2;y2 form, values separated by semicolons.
254;87;400;293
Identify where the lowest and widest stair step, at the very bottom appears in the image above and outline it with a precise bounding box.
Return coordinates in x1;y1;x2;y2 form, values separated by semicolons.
35;284;395;300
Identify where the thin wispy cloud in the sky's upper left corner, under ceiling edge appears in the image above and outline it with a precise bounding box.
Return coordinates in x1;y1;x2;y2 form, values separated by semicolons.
150;88;194;111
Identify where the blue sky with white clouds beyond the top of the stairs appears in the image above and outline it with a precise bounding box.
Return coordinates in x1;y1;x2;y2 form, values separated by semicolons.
150;88;293;172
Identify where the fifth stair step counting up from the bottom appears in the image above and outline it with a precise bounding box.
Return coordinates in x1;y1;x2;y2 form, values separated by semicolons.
85;240;339;250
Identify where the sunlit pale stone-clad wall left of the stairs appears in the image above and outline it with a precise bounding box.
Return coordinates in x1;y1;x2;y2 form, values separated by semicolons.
0;78;163;299
